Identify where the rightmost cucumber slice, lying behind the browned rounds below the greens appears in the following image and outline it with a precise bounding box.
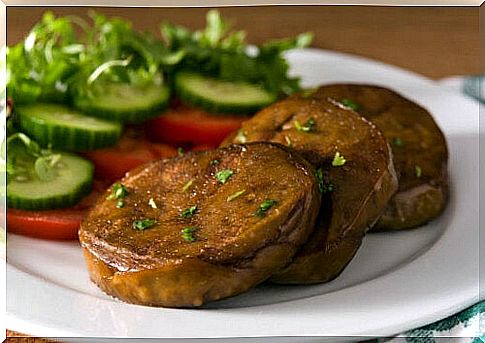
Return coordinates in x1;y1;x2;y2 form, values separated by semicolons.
175;72;276;114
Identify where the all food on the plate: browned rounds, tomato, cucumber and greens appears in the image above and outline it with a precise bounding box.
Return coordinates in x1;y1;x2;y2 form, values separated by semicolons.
2;11;449;307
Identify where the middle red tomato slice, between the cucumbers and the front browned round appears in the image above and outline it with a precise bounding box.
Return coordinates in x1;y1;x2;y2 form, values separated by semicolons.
84;130;177;181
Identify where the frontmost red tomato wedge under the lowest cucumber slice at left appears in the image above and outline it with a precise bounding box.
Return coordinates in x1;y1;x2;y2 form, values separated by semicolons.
7;181;107;240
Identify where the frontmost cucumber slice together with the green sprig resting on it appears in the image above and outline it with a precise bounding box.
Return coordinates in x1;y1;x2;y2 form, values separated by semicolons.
7;133;94;210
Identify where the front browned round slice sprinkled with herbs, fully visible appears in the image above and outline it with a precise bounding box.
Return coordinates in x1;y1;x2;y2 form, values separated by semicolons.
79;143;321;307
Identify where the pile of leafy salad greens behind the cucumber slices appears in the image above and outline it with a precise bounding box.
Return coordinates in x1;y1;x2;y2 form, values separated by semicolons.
6;10;312;103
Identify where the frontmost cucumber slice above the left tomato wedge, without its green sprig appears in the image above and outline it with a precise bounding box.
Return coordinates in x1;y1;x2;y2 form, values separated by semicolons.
7;153;94;210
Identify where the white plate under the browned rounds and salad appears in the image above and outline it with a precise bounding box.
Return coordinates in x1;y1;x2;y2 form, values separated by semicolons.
3;49;484;338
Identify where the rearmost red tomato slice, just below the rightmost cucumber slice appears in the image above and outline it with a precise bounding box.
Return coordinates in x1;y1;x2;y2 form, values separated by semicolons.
146;105;248;146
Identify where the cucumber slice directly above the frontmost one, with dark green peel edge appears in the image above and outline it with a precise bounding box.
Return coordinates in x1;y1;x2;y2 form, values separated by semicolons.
15;103;122;151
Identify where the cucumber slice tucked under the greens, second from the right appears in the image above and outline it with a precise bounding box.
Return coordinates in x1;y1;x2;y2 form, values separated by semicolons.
74;83;170;123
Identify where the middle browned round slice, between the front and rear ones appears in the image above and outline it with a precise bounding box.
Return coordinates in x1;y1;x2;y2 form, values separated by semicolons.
223;95;397;284
